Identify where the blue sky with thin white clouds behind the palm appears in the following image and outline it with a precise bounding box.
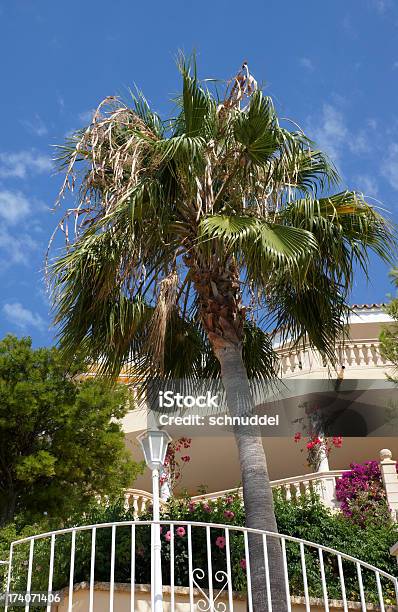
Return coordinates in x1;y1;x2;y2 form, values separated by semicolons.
0;0;398;345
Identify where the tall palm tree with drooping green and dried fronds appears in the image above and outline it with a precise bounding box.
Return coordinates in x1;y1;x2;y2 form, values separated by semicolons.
50;57;393;612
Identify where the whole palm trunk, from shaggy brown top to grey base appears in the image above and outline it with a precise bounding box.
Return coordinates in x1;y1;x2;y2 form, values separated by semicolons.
190;255;287;612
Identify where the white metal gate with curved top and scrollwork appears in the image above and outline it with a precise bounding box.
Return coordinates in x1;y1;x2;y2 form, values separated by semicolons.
2;521;398;612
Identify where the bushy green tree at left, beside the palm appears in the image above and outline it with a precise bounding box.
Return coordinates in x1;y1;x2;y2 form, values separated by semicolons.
0;336;140;525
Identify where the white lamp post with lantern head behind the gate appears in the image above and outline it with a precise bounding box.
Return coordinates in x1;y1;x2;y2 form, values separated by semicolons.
137;429;171;612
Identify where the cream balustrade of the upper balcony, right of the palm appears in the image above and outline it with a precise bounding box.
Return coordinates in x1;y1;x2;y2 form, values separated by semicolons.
277;340;389;376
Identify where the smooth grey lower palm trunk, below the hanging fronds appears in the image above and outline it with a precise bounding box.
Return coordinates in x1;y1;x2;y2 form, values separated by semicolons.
215;344;288;612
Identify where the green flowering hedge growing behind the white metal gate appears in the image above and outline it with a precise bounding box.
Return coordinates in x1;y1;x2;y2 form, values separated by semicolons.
0;492;398;602
